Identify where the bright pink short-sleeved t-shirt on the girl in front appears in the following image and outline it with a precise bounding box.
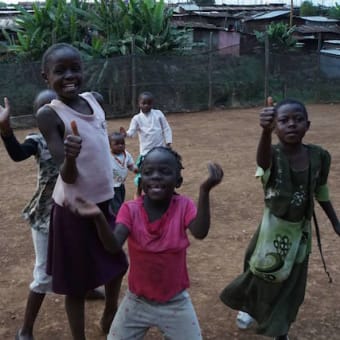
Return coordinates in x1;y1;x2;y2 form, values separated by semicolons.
116;195;197;302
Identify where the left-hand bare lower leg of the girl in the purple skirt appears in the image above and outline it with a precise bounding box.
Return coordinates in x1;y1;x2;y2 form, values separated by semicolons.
65;295;86;340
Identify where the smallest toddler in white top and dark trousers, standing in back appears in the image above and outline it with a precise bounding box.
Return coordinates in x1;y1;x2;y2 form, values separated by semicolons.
109;132;138;215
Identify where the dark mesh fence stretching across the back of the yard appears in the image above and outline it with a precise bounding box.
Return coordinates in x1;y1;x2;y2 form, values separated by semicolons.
0;48;340;126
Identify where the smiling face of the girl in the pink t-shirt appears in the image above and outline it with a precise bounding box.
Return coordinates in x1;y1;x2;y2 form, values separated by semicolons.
141;149;181;201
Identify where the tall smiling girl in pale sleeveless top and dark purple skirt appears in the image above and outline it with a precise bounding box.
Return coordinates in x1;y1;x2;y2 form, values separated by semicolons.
37;43;128;340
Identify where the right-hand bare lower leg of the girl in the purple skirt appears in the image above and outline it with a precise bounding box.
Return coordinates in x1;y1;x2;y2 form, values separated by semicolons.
100;274;124;334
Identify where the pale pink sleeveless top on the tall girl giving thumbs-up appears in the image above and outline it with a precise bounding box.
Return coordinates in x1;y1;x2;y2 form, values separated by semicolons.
48;92;114;206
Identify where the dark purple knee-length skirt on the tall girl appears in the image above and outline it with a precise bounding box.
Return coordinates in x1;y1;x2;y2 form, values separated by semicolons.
46;201;128;296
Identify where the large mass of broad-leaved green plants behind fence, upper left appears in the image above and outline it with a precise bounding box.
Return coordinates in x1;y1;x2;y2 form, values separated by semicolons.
4;0;191;61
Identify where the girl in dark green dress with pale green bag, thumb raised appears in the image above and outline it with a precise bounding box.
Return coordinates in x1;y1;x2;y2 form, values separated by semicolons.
221;99;340;340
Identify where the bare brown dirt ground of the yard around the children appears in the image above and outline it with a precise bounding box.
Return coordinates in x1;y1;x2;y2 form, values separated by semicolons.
0;105;340;340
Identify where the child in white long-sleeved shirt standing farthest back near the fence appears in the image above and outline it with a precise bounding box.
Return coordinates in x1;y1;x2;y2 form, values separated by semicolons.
120;92;172;196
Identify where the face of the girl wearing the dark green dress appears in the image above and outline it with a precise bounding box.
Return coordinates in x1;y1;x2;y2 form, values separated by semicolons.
275;103;310;144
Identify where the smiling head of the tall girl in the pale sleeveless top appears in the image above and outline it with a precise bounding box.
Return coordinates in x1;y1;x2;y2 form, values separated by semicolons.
43;46;83;99
